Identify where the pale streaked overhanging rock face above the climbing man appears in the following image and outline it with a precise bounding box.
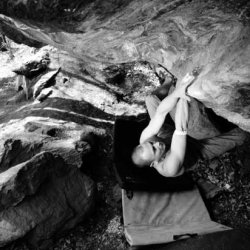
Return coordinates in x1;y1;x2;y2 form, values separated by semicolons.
0;0;250;131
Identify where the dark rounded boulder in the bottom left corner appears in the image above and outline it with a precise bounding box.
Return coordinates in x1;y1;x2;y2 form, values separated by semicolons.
0;152;95;248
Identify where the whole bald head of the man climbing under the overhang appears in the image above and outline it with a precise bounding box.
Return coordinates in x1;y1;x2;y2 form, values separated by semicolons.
132;141;166;167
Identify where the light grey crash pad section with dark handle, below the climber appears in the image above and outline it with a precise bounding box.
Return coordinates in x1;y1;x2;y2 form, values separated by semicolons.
122;187;231;246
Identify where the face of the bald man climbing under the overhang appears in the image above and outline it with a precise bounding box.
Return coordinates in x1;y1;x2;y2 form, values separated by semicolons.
140;141;166;165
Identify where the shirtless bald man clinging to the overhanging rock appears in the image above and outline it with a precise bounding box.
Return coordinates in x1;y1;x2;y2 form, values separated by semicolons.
132;71;248;177
